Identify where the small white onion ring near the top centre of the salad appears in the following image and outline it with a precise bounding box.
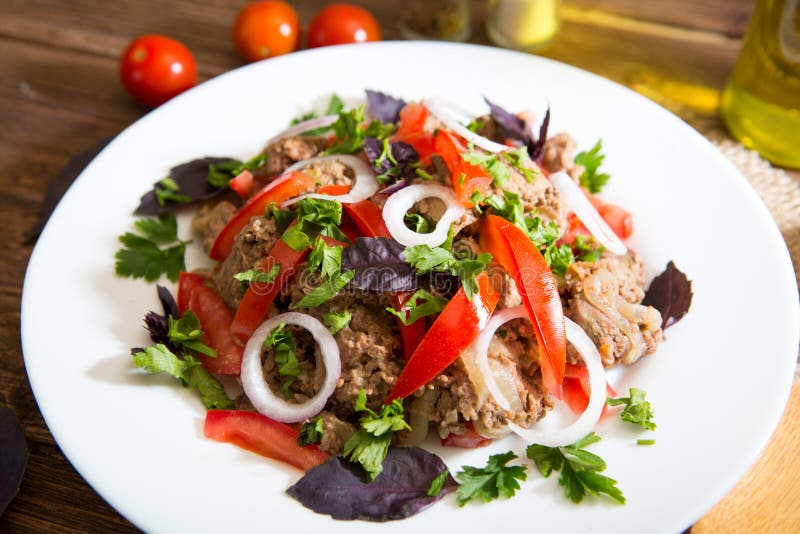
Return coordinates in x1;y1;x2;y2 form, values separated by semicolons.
383;184;466;247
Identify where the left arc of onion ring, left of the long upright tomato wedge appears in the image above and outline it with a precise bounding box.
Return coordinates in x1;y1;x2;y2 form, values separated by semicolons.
462;304;528;412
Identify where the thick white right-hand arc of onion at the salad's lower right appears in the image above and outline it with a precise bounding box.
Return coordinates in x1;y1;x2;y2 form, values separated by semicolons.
508;317;606;447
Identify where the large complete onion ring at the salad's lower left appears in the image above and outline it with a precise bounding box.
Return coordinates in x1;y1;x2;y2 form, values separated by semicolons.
241;312;342;423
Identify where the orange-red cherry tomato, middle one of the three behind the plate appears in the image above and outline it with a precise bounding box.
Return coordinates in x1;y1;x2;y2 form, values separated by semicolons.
238;0;300;61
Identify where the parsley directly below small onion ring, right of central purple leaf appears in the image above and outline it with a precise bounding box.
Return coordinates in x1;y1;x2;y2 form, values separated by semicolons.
403;245;492;300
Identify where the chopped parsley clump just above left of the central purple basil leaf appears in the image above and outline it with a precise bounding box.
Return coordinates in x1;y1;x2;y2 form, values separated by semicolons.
281;198;350;252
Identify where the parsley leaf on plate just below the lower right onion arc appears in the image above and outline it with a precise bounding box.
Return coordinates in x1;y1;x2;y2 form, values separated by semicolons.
526;432;625;504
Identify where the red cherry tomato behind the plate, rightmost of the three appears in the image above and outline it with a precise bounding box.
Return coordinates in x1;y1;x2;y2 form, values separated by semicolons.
308;4;381;48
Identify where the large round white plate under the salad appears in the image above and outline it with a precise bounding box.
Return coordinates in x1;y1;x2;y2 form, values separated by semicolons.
22;42;800;533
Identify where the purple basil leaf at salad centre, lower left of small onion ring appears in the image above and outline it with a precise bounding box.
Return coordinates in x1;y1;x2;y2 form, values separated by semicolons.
342;237;417;291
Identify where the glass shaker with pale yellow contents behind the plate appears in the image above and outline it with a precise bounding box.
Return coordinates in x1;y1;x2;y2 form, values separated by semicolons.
486;0;561;52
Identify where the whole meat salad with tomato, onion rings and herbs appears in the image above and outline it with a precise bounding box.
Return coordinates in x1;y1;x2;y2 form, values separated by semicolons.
116;91;692;520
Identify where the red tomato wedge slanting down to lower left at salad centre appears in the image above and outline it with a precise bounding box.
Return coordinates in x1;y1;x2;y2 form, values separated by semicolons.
386;272;500;404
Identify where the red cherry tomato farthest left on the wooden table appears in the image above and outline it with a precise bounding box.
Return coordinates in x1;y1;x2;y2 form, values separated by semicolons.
120;34;197;107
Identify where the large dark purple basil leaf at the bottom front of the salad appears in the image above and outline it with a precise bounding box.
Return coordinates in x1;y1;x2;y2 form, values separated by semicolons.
286;447;458;521
